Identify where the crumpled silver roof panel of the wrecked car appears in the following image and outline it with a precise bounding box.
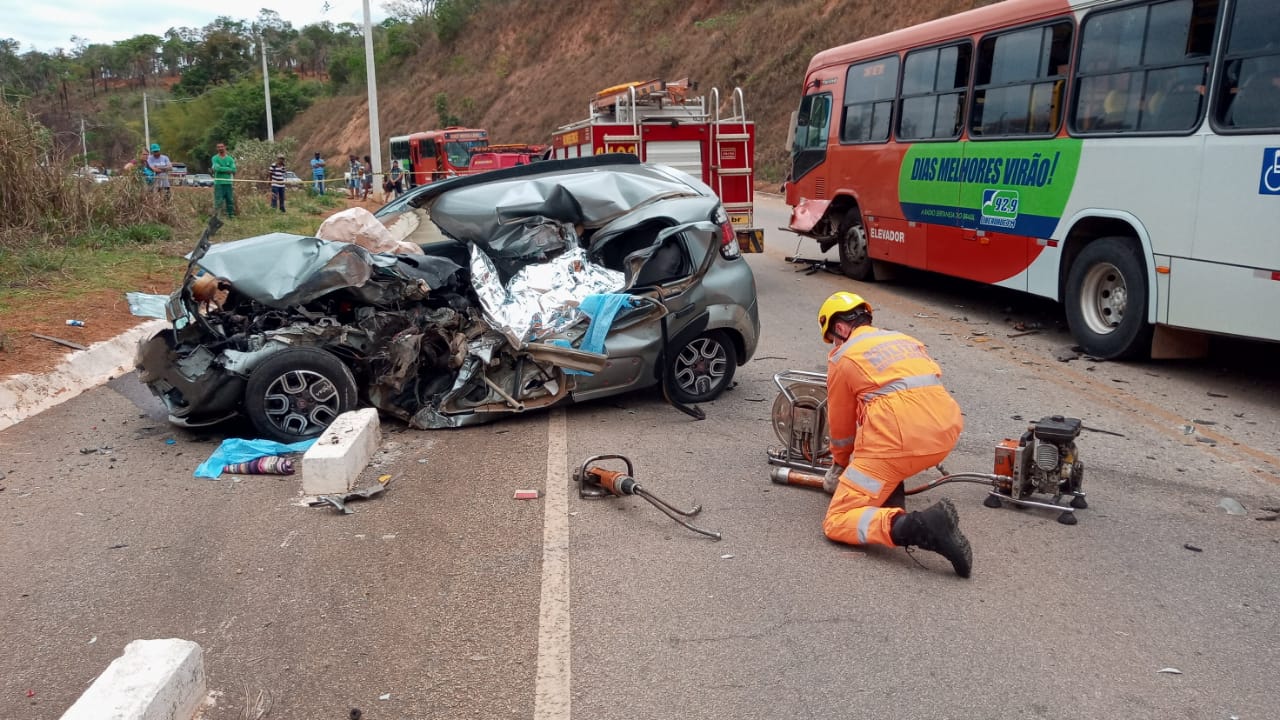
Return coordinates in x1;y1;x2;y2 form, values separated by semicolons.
431;170;698;249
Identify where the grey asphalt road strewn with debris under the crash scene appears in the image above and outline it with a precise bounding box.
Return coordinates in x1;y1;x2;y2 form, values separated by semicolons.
0;192;1280;720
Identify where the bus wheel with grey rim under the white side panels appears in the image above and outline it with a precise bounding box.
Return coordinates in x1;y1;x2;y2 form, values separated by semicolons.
1066;237;1152;360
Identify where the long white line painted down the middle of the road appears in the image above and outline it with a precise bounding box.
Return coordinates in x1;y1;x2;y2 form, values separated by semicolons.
534;409;570;720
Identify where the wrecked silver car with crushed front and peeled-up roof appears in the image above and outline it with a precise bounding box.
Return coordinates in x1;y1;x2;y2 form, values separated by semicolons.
137;155;760;442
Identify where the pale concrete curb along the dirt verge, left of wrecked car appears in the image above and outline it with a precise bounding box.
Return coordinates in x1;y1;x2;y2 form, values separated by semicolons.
0;320;169;430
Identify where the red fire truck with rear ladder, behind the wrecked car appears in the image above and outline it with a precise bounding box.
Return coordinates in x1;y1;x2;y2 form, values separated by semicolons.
552;78;764;252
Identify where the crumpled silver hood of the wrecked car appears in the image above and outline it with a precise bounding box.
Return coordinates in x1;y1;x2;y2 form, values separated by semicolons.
198;232;461;309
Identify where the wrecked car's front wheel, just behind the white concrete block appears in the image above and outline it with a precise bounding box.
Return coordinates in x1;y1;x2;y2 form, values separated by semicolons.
244;347;358;443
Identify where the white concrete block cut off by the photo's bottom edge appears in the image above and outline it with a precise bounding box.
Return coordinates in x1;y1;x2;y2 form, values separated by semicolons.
63;638;205;720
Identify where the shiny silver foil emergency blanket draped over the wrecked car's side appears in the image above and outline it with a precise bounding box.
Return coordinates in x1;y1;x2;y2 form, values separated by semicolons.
471;238;626;347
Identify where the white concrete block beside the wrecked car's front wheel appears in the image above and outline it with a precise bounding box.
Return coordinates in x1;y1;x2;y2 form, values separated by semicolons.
302;407;383;495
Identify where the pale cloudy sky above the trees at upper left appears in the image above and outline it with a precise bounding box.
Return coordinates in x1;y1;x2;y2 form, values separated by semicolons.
0;0;387;53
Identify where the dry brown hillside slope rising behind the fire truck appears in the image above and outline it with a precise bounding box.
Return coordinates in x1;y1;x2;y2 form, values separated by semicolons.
284;0;992;181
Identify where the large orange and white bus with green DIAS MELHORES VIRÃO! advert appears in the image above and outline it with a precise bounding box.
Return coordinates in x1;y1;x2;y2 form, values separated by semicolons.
786;0;1280;357
